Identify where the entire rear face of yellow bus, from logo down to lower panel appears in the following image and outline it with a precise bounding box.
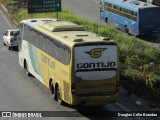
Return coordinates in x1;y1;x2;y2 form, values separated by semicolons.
74;44;118;96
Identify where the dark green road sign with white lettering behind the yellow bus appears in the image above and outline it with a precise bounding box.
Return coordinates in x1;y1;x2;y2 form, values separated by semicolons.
28;0;61;14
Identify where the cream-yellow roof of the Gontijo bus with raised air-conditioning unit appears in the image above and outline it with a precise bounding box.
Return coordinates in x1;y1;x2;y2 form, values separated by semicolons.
22;18;114;45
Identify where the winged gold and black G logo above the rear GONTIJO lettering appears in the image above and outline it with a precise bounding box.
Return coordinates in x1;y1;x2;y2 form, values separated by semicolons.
85;48;107;58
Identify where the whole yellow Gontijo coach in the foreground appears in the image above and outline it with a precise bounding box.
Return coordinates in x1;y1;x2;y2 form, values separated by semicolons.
19;18;119;106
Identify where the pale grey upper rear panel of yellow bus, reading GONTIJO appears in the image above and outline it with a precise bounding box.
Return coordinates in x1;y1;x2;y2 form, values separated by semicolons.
75;45;118;80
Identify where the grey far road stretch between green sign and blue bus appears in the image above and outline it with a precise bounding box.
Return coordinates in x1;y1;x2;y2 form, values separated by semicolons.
62;0;100;22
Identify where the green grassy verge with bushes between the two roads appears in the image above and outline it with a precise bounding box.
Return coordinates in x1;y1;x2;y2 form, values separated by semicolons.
3;0;160;106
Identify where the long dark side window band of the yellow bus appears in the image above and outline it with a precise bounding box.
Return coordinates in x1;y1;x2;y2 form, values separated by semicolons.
24;25;70;64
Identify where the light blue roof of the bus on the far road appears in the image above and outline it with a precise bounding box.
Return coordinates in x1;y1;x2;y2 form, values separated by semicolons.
107;0;157;11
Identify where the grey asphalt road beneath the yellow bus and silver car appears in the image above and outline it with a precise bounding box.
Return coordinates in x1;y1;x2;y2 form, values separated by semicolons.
0;3;158;120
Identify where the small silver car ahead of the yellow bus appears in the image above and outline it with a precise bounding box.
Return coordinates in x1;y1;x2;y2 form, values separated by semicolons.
3;29;19;50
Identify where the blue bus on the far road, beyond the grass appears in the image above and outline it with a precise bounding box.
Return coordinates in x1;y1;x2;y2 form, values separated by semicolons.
100;0;160;36
